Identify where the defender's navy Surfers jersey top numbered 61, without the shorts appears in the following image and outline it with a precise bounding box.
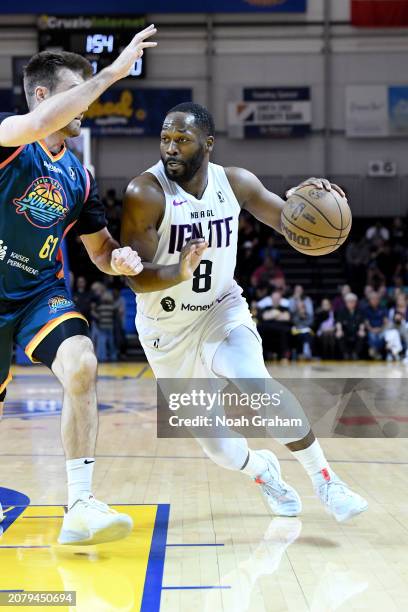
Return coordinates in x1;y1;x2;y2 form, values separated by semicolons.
0;115;106;302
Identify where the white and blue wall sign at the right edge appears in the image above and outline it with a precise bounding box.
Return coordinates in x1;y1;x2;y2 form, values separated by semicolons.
346;85;408;138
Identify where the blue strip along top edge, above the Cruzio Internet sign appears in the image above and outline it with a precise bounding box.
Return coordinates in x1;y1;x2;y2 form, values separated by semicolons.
0;0;307;15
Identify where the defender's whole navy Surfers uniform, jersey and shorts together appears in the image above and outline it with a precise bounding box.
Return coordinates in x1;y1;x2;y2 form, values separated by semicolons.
0;114;106;392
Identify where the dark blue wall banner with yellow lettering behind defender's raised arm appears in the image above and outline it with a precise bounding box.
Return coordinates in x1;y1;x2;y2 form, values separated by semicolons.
83;87;192;136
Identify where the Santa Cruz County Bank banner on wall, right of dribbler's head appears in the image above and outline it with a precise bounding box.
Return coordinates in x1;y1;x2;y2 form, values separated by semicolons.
228;87;312;138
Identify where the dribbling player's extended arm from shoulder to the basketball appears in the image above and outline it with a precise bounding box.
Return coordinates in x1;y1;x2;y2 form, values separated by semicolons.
225;168;285;233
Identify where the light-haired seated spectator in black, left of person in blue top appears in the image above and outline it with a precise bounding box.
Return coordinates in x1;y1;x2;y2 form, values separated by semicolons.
335;293;367;360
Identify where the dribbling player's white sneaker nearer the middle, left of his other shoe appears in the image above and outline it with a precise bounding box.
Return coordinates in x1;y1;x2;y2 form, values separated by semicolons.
254;450;302;516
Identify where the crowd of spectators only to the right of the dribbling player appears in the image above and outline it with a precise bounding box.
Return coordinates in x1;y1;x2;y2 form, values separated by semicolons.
236;214;408;363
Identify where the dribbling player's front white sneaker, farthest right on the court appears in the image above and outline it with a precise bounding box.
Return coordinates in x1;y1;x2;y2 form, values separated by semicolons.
313;469;368;523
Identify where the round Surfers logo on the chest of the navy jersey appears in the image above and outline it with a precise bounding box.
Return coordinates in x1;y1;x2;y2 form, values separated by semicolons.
13;176;69;228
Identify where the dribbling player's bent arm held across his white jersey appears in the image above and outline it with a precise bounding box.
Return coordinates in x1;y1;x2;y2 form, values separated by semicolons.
121;174;208;293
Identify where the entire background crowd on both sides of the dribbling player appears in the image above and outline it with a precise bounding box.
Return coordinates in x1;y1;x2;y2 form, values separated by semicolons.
70;189;408;363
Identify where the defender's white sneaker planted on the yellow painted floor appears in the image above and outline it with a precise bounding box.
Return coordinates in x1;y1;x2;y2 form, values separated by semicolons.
58;496;133;545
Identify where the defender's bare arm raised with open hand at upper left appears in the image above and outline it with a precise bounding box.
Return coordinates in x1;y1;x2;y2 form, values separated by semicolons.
0;25;157;147
